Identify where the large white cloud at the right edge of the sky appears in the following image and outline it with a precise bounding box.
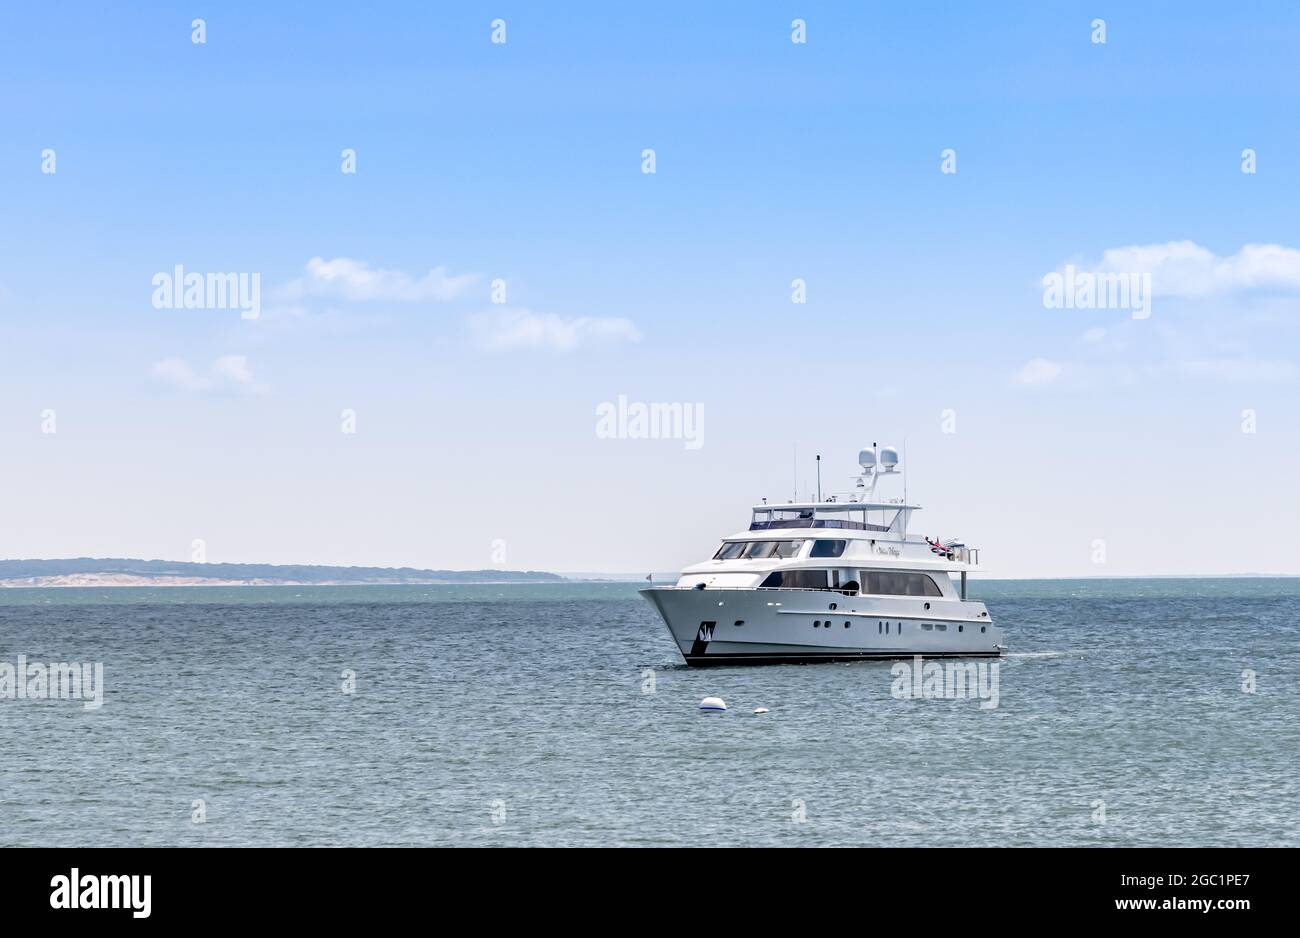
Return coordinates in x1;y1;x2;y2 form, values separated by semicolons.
1093;240;1300;298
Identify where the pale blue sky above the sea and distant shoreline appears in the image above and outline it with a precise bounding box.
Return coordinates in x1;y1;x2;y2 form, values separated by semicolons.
0;3;1300;576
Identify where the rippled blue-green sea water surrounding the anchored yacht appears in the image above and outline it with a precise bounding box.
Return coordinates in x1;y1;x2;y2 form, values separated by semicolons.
0;578;1300;846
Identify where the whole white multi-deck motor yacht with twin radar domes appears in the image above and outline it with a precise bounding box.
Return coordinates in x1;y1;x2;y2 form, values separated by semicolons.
641;447;1004;665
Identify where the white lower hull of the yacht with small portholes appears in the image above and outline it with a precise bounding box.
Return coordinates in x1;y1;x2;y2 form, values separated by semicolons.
641;586;1004;666
